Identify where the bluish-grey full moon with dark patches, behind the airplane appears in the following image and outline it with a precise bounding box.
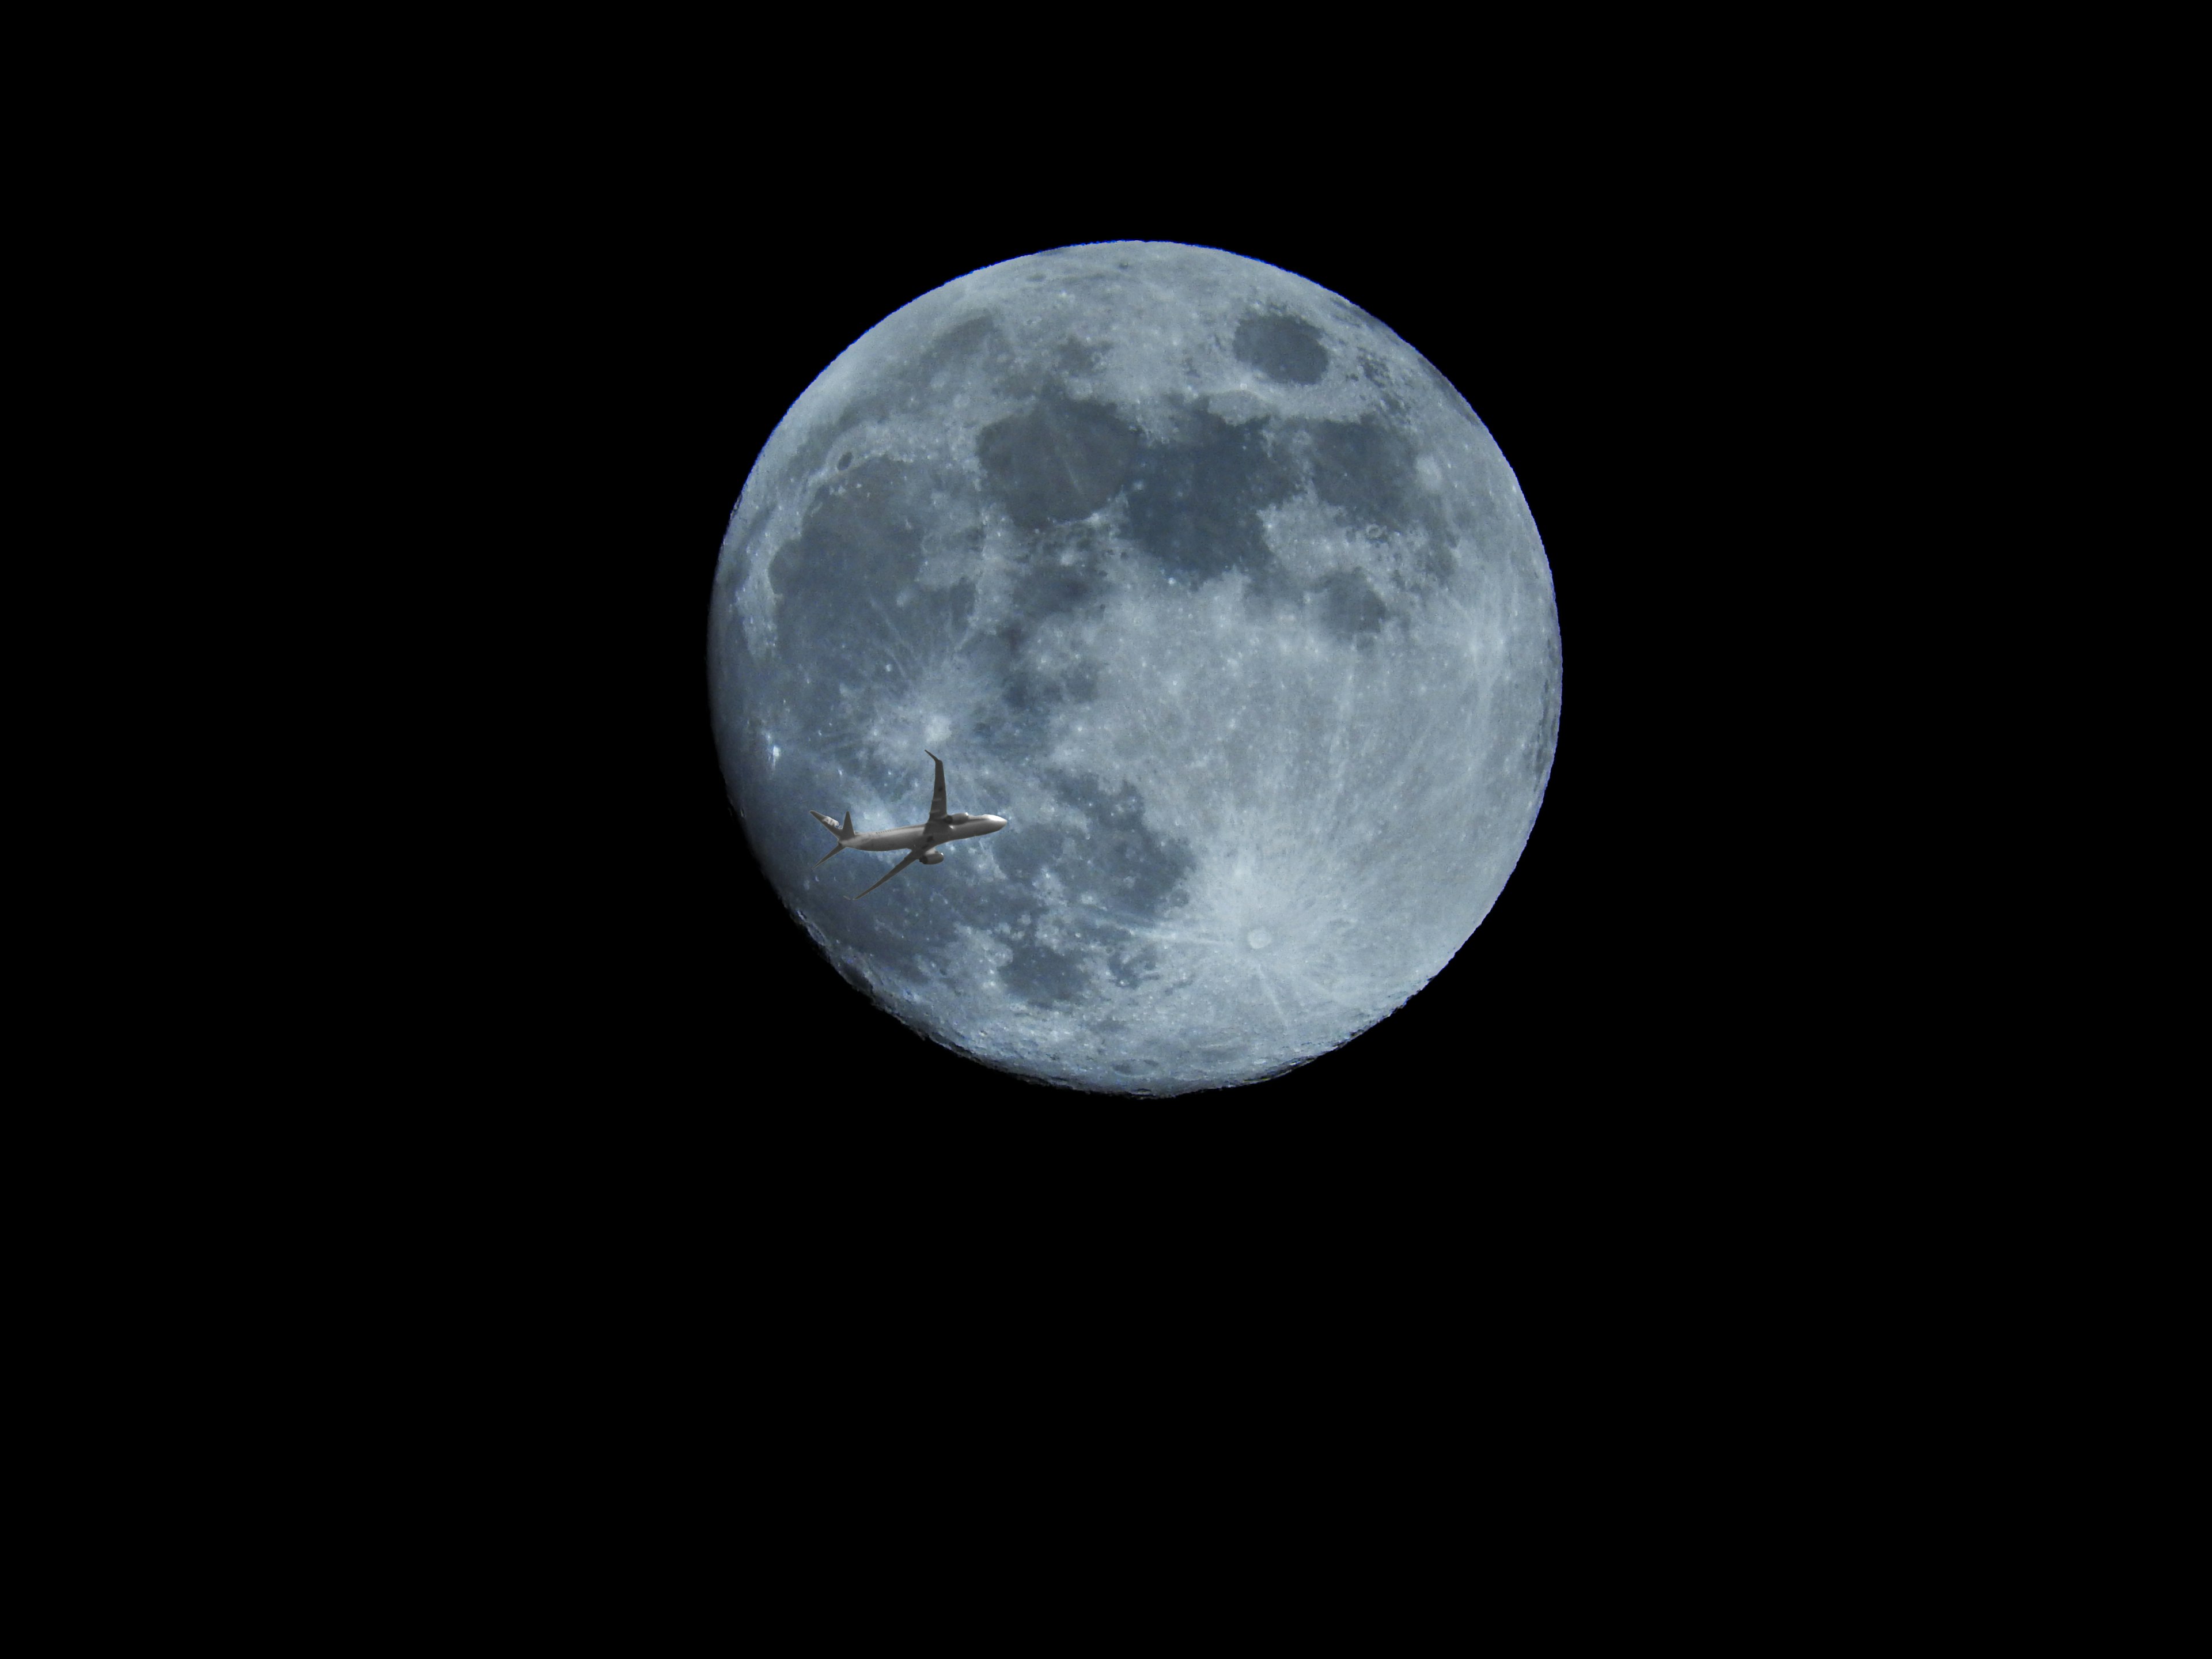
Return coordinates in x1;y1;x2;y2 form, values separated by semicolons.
708;243;1559;1095
